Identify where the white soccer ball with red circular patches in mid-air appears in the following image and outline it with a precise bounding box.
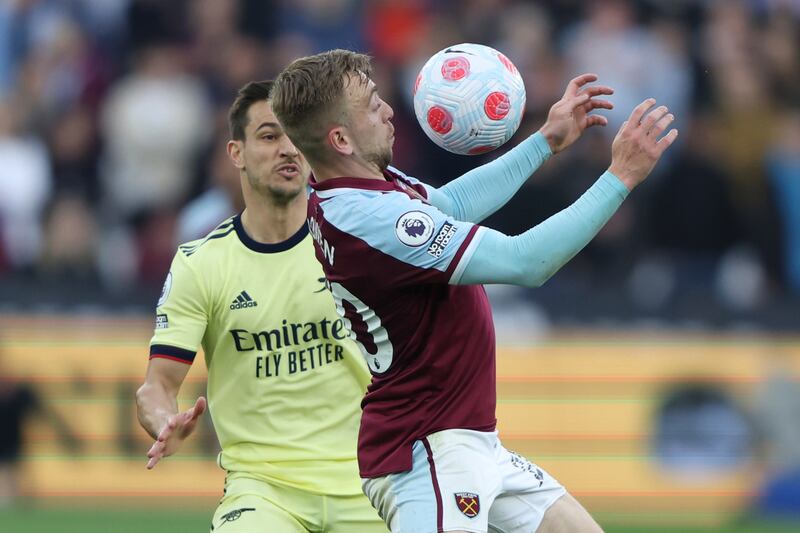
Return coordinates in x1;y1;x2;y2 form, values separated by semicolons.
414;43;525;155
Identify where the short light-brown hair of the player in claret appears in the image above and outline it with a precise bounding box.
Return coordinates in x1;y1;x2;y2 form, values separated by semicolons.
272;49;372;161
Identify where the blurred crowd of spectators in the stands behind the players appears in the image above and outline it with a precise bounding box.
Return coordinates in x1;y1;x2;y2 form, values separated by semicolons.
0;0;800;322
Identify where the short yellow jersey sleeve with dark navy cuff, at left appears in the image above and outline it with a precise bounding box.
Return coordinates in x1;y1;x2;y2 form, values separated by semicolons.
150;251;208;364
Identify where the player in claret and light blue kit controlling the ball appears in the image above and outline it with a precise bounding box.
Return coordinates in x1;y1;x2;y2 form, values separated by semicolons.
273;50;677;533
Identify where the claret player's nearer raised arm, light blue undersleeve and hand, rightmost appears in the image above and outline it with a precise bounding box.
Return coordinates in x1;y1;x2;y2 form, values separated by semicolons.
455;95;678;287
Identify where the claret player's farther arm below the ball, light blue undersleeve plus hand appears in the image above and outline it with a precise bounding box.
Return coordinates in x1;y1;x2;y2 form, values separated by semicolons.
426;74;613;223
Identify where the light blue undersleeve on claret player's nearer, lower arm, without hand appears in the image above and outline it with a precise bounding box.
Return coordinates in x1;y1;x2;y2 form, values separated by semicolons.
455;172;628;287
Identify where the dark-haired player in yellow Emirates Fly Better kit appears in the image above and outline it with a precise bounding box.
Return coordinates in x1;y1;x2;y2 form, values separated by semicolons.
136;82;386;533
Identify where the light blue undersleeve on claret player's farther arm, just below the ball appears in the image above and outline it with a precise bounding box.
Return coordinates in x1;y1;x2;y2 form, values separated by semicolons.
425;132;552;223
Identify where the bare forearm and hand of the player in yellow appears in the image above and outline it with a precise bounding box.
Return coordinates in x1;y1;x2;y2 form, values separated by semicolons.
136;358;206;469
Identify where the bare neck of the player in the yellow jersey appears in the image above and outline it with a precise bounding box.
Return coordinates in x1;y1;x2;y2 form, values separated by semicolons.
242;185;308;244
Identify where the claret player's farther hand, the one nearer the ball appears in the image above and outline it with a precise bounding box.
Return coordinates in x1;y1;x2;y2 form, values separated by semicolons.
540;74;614;154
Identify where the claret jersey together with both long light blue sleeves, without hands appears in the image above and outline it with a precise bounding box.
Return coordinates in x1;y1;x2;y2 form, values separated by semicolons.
308;132;628;478
